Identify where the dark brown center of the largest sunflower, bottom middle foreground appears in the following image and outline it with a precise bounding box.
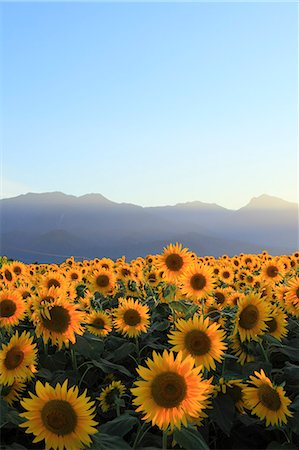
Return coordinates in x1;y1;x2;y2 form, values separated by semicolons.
151;372;187;408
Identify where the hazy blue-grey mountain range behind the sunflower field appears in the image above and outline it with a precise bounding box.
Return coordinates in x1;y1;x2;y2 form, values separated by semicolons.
0;192;299;263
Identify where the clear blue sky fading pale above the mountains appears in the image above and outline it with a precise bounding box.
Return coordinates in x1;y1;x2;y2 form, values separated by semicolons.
1;3;298;209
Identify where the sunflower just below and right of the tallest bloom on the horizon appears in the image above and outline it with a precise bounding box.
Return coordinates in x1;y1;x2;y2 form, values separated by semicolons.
179;263;214;301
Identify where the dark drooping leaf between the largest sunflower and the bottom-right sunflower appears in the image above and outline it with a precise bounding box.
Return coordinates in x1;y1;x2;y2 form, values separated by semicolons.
210;394;235;436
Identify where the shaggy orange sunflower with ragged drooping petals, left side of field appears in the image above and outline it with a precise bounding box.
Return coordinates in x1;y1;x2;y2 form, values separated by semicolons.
32;297;85;349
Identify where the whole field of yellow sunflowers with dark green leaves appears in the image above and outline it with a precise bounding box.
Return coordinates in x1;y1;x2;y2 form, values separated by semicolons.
0;243;299;450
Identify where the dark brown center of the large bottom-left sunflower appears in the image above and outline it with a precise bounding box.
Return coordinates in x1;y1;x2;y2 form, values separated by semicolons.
41;400;78;436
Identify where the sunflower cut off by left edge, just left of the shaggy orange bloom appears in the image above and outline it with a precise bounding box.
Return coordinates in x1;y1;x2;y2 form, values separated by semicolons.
0;288;26;329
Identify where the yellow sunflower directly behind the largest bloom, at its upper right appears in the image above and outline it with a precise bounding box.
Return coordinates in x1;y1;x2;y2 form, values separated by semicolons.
168;316;227;370
